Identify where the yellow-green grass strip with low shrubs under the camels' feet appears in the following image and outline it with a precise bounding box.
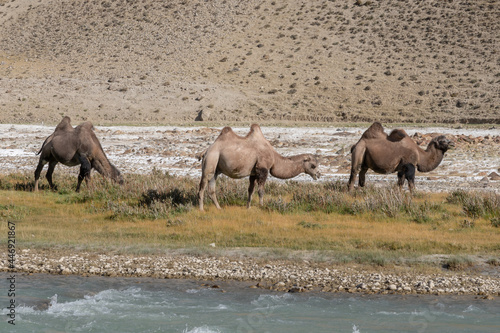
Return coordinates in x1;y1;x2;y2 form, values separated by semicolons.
0;172;500;265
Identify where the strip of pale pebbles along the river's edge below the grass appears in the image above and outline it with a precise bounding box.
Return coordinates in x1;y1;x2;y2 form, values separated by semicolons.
0;249;500;299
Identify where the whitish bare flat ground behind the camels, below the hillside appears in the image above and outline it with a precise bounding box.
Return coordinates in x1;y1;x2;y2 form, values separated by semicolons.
0;124;500;193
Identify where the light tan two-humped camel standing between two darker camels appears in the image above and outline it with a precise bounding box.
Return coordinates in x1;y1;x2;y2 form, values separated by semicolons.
198;124;320;210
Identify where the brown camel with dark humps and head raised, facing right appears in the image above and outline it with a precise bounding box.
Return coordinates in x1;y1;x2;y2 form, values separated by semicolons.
347;122;453;191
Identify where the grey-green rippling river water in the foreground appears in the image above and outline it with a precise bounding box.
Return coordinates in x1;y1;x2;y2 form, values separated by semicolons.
0;273;500;333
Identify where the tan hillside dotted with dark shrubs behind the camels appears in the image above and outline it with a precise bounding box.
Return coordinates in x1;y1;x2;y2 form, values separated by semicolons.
0;0;500;124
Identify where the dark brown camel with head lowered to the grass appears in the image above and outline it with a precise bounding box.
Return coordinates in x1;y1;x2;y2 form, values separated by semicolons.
35;117;123;192
